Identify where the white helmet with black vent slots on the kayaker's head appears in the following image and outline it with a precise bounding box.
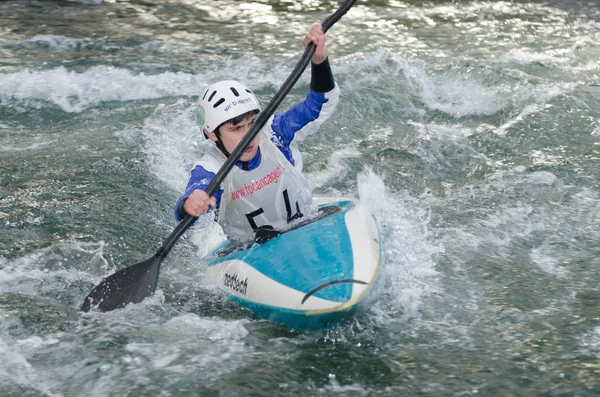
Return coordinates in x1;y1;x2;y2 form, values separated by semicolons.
196;80;260;132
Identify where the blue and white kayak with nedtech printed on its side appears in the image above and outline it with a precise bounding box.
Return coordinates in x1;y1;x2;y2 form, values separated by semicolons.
203;198;383;330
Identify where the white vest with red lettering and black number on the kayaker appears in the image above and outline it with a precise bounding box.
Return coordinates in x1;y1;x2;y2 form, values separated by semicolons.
219;131;317;241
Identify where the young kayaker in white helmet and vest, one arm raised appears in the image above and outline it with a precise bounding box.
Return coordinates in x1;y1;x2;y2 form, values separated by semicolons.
175;24;339;241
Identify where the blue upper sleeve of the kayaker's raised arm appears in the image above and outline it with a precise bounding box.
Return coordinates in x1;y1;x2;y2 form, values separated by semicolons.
271;89;329;146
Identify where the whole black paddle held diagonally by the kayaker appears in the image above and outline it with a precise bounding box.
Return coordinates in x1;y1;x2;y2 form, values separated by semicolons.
80;0;356;312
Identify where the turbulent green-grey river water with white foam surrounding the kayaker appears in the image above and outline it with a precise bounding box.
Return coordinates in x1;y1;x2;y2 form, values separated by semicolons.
0;0;600;397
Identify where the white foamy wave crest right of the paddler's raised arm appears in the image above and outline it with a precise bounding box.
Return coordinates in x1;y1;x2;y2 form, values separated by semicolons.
341;49;578;119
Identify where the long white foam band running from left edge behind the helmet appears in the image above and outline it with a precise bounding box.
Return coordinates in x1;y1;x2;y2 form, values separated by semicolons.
0;57;288;113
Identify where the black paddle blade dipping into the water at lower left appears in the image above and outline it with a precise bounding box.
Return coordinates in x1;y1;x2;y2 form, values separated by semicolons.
80;255;163;312
